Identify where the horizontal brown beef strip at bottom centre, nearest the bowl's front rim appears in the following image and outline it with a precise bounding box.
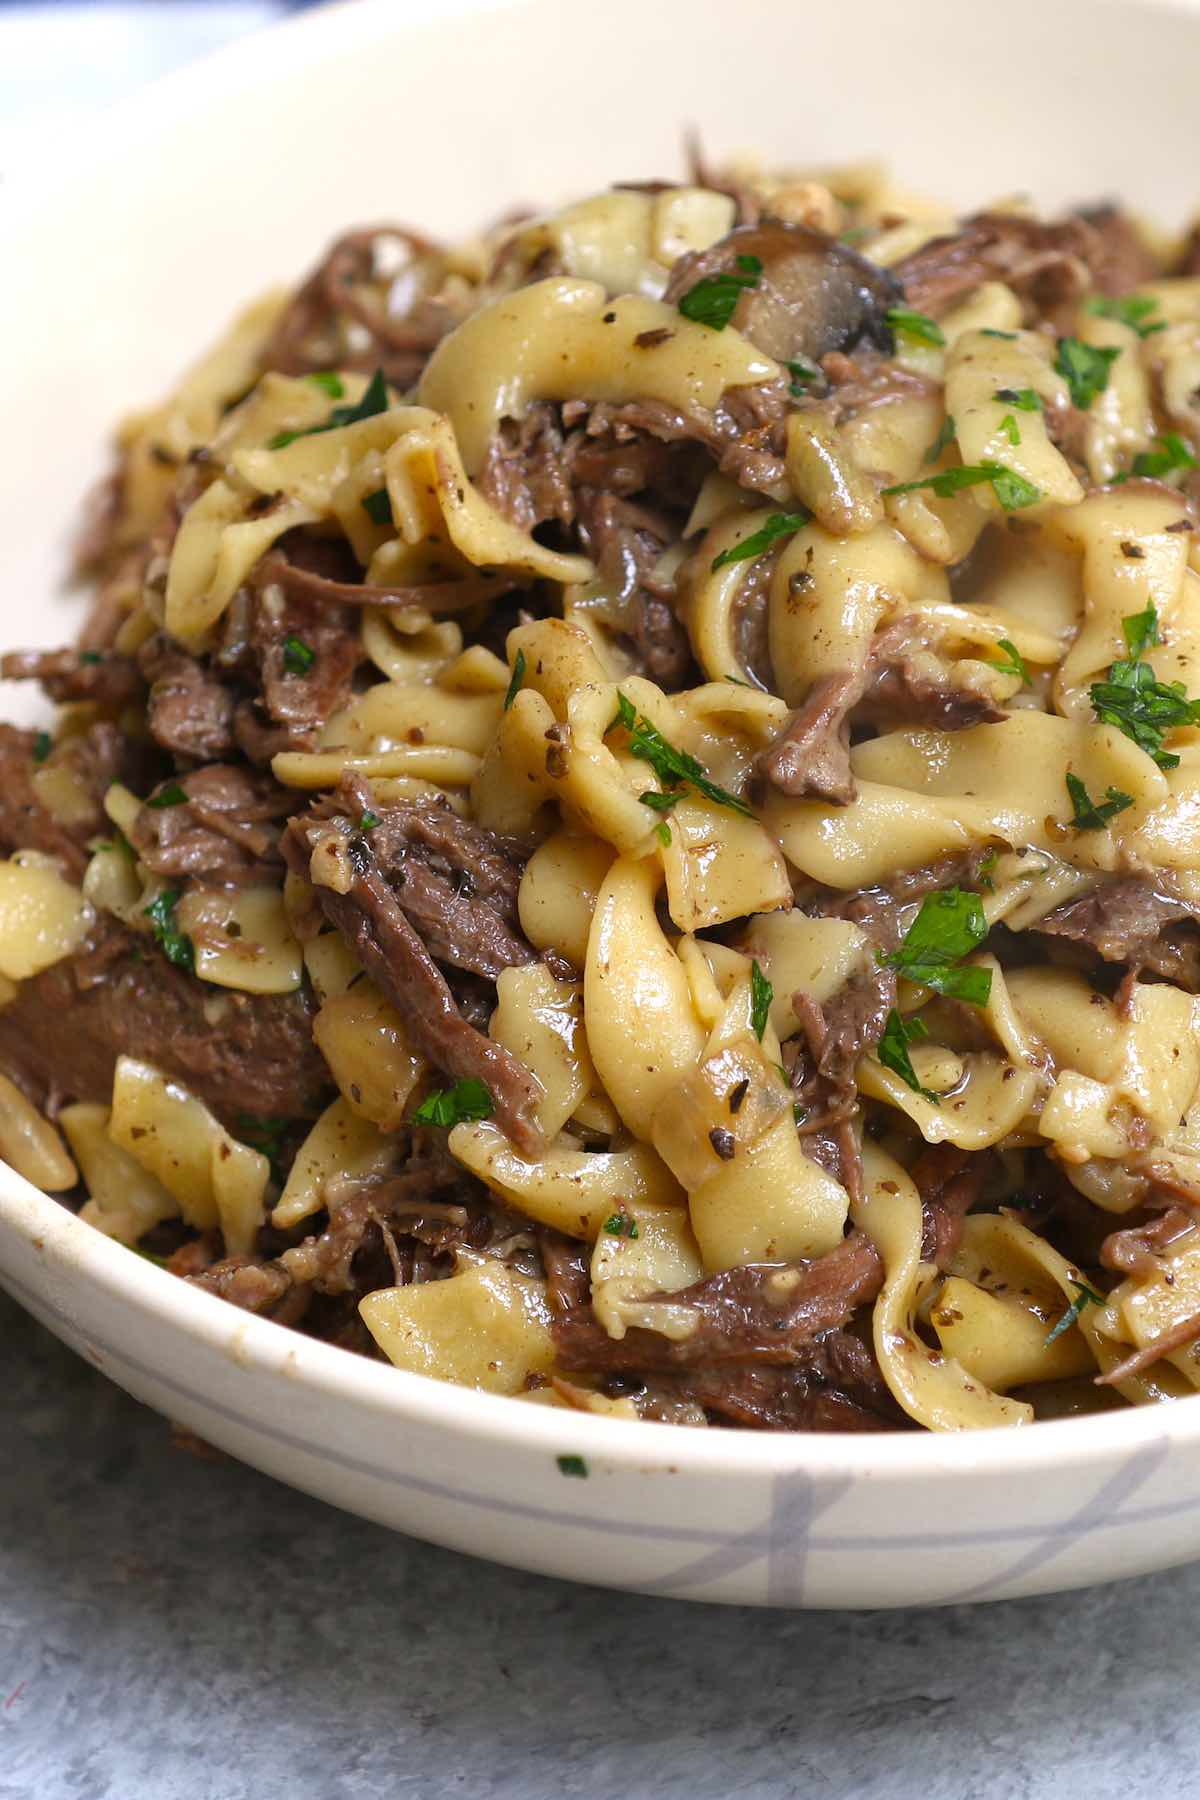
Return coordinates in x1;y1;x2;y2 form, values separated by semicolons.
551;1231;883;1372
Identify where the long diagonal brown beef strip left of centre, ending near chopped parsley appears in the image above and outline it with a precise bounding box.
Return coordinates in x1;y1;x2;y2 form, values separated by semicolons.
282;788;542;1154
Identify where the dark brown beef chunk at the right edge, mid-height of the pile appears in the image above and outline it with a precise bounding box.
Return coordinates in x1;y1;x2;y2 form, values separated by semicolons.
1033;875;1200;994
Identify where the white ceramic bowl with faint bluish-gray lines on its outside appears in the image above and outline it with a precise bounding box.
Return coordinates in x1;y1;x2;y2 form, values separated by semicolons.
0;0;1200;1606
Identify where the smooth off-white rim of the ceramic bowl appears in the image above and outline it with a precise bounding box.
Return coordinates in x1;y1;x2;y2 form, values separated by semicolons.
0;0;1200;1483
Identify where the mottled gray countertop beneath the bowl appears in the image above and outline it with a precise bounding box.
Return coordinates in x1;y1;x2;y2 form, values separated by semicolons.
0;1296;1200;1800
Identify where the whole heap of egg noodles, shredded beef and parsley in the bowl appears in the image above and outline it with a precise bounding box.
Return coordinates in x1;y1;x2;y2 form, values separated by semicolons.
0;158;1200;1431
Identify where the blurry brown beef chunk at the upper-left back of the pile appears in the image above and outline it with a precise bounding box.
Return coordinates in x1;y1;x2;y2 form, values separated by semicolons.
263;225;459;391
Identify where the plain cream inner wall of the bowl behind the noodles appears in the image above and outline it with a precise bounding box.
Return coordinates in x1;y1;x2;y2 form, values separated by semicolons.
0;0;1200;1490
